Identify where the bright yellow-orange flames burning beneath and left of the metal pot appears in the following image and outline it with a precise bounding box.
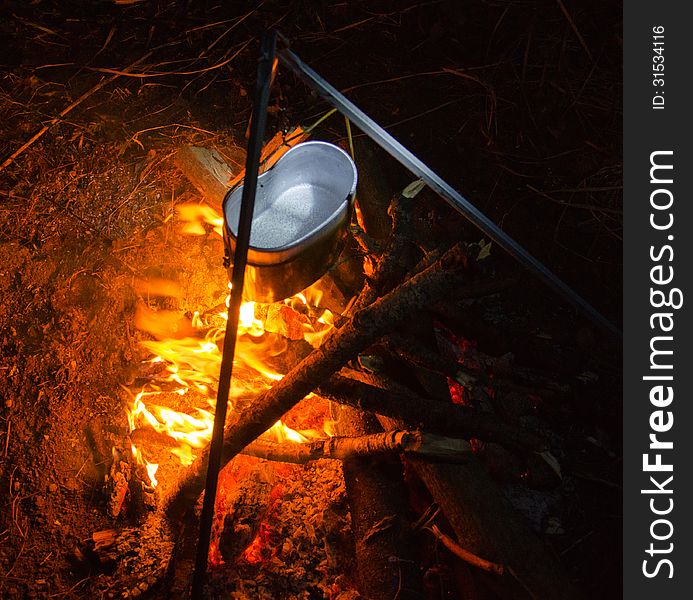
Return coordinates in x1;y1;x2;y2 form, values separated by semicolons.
128;203;334;476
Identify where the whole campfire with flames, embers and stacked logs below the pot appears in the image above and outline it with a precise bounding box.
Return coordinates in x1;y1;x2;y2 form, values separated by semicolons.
5;102;612;598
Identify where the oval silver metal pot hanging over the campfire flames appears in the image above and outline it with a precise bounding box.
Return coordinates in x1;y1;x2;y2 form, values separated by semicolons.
223;141;357;302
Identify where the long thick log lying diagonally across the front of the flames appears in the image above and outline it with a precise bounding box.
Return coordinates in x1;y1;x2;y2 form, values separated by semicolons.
164;245;464;521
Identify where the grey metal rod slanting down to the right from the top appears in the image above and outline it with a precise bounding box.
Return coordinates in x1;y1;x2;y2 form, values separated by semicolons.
278;49;623;336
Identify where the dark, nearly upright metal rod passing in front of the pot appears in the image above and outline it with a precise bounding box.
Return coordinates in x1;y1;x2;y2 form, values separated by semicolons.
190;32;277;600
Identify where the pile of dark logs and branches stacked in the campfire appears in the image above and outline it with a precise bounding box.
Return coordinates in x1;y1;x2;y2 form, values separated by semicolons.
60;135;600;598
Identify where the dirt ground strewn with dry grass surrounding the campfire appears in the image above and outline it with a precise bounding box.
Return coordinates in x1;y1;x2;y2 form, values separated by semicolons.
0;0;622;598
